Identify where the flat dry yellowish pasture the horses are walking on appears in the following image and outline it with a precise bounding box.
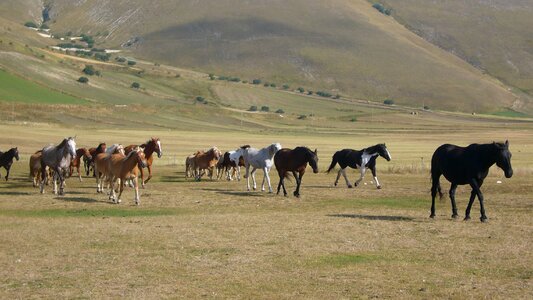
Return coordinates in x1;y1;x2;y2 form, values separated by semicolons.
0;121;533;298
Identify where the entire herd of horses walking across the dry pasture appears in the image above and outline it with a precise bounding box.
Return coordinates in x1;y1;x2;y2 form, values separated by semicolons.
0;137;513;222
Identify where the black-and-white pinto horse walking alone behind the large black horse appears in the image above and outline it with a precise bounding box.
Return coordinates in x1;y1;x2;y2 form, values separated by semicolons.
327;144;391;189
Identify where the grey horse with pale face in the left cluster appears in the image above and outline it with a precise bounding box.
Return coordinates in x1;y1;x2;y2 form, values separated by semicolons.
41;137;76;195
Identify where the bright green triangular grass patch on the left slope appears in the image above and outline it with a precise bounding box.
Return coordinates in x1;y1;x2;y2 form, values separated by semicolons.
0;70;86;104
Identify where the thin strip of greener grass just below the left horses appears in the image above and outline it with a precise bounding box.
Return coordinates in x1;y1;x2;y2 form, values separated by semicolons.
0;208;185;218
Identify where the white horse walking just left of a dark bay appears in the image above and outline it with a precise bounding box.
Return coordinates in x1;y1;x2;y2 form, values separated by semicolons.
242;143;281;193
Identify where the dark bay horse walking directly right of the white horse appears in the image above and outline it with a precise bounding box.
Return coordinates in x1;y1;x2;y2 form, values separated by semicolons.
274;147;318;197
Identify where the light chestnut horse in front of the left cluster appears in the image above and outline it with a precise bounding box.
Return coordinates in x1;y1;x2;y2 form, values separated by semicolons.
108;147;147;205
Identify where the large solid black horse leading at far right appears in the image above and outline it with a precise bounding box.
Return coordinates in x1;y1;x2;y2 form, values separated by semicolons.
430;141;513;222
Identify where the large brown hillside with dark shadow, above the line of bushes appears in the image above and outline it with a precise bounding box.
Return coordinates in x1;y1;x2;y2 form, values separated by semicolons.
0;0;529;112
